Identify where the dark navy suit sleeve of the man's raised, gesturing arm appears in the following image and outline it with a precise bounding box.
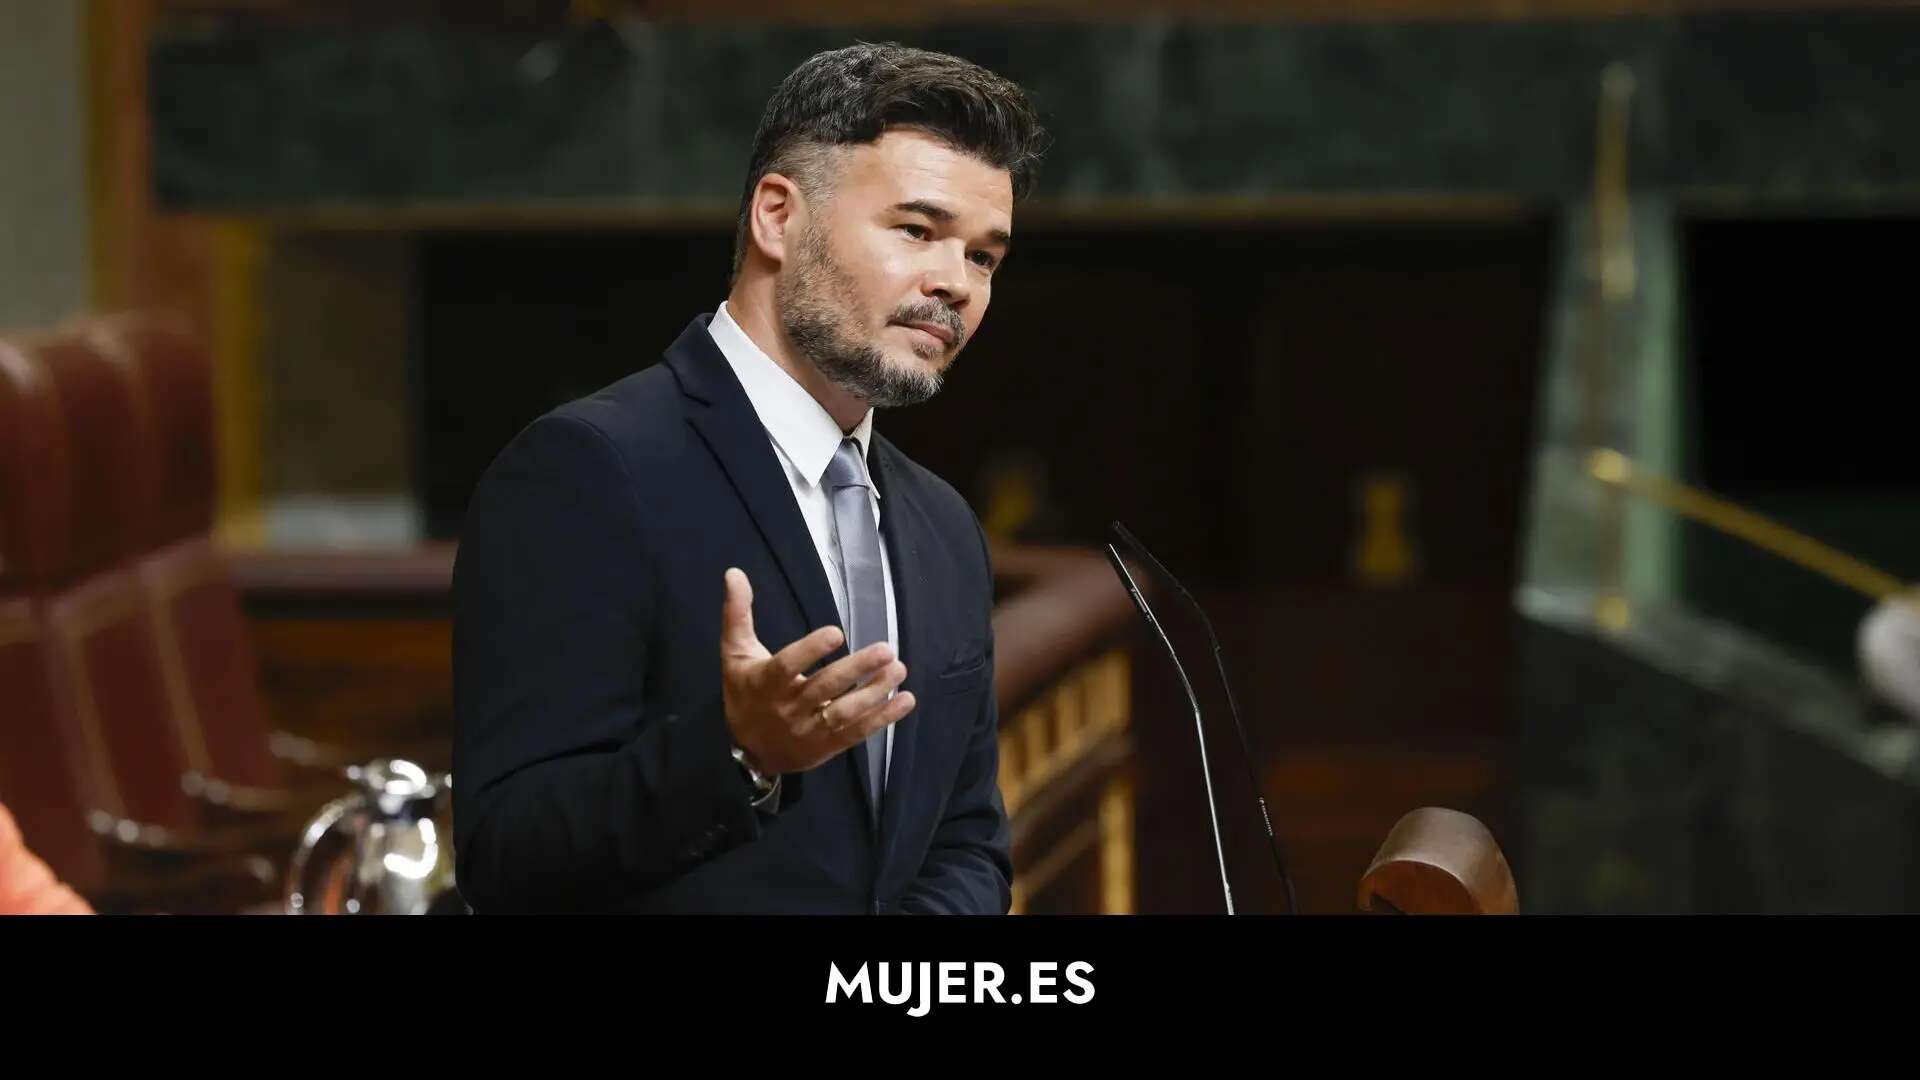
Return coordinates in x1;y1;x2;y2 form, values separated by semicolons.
453;415;758;911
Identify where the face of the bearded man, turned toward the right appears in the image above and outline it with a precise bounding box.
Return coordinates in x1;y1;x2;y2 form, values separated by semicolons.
776;131;1014;407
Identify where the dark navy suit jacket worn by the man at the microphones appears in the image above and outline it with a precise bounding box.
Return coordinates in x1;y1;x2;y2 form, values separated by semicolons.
453;315;1012;915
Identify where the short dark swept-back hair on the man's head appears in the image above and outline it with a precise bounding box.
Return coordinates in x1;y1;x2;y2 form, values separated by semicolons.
733;42;1046;275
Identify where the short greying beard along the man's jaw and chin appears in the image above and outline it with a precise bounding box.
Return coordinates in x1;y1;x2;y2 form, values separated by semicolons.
774;223;966;409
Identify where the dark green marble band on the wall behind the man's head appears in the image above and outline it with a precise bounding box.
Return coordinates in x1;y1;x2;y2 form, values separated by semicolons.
152;12;1920;209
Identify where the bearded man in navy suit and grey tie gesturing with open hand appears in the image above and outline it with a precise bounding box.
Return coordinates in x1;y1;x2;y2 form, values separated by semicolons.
453;44;1043;915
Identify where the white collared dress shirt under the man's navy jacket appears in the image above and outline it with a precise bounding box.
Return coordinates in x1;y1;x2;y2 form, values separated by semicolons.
707;302;900;771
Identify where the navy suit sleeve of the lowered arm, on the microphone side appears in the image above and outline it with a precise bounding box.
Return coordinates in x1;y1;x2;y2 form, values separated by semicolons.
900;515;1014;915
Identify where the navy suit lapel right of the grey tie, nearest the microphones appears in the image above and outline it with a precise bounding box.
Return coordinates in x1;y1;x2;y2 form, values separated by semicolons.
868;438;937;865
